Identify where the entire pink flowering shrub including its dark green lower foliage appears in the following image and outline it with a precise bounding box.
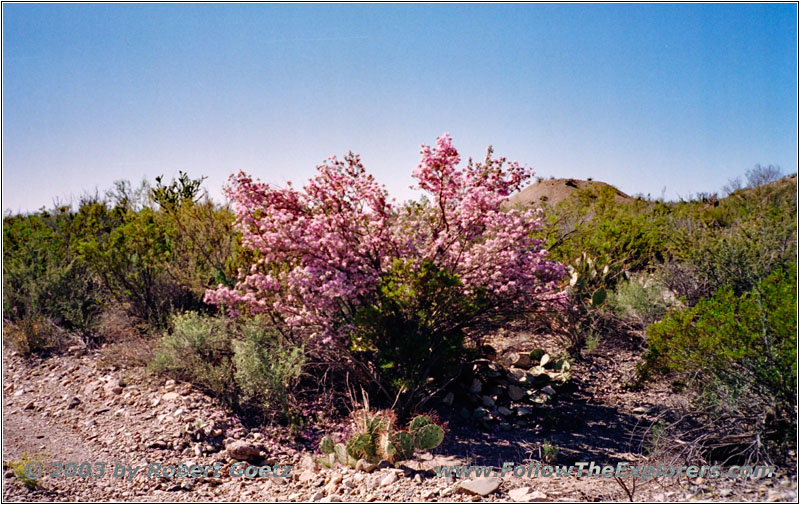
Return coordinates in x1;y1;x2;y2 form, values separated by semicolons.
206;134;565;410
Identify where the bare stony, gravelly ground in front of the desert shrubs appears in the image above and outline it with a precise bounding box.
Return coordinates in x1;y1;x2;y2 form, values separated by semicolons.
3;334;797;502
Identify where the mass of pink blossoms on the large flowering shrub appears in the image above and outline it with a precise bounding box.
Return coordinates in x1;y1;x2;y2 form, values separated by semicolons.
205;134;566;344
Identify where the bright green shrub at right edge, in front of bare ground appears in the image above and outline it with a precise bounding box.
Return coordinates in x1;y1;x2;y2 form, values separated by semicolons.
639;265;797;457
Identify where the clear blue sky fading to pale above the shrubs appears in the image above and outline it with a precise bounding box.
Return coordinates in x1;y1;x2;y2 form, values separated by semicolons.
2;4;798;211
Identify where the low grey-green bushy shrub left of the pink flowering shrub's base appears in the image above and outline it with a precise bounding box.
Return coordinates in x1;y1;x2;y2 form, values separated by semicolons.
150;312;304;412
